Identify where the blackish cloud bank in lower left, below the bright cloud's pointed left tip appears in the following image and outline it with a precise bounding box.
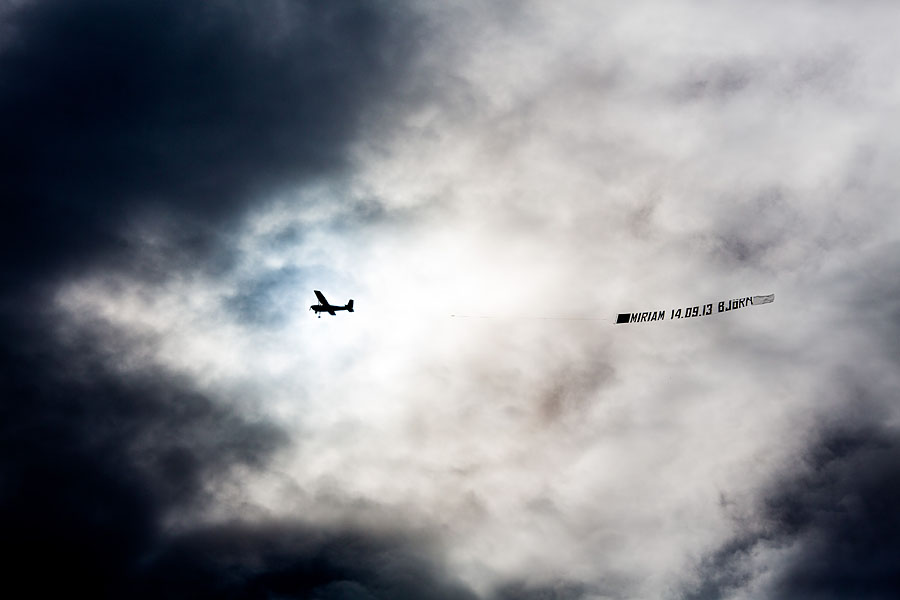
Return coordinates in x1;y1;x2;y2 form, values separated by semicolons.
0;318;500;600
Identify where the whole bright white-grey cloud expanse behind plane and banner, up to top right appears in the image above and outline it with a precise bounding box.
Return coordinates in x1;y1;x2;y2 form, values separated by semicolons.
12;2;900;597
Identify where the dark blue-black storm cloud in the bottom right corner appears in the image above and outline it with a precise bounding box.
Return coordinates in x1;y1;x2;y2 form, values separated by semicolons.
768;428;900;598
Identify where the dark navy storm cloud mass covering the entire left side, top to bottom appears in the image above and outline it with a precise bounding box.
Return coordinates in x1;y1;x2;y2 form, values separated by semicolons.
0;0;472;598
